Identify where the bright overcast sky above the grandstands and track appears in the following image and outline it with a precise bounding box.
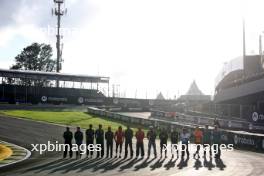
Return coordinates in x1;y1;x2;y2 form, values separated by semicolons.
0;0;264;98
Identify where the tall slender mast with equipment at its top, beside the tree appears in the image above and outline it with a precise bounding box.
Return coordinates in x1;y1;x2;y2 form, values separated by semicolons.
52;0;67;87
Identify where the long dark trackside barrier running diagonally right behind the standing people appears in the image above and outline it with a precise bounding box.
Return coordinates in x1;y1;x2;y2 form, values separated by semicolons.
87;107;264;152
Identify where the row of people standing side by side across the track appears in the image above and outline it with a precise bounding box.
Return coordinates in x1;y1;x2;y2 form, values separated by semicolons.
63;124;220;158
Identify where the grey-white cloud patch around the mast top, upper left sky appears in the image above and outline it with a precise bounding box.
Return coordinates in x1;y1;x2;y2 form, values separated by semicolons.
0;0;96;47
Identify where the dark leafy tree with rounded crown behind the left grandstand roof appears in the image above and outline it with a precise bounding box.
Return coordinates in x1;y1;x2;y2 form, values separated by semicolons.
11;43;56;86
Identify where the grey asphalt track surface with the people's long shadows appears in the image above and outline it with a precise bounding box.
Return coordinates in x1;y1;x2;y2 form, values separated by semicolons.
0;116;264;176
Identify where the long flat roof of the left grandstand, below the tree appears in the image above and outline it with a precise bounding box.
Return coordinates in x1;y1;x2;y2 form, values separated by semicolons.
0;69;110;83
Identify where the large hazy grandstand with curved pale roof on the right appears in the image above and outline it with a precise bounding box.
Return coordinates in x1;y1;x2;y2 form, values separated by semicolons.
213;55;264;123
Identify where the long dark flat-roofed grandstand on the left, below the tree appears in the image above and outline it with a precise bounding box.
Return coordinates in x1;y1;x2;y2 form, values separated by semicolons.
0;69;109;104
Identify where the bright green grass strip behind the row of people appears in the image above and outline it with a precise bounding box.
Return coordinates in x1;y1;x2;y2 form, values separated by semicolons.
0;110;146;132
